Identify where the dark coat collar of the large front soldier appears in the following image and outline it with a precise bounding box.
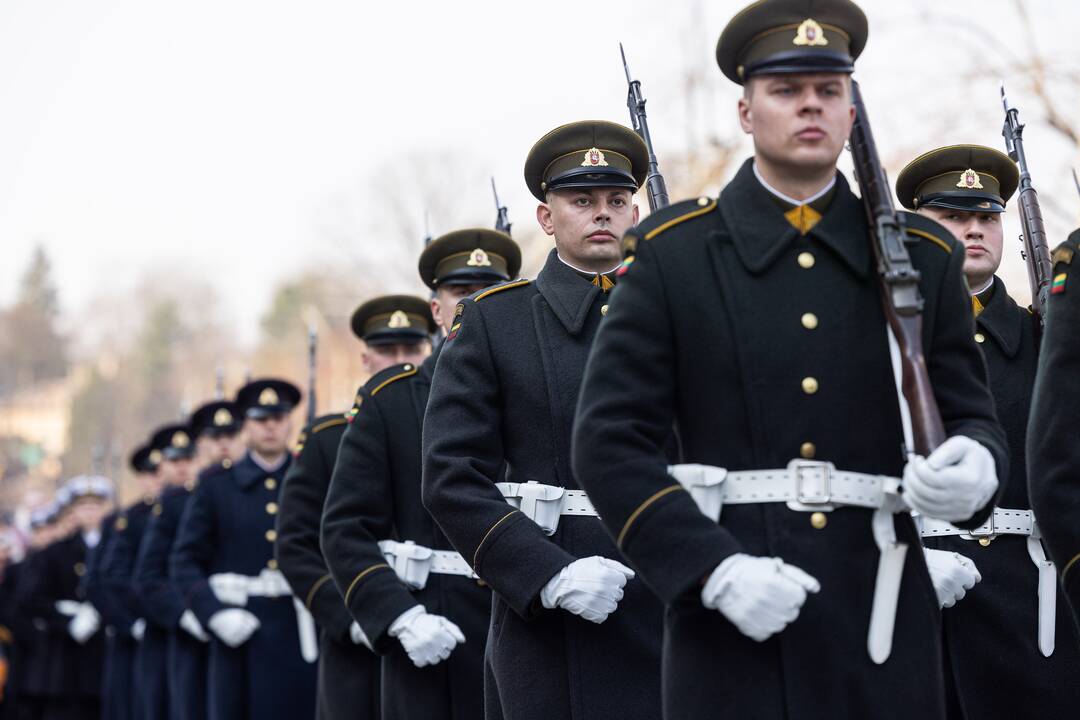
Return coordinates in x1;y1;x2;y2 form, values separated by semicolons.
719;159;870;277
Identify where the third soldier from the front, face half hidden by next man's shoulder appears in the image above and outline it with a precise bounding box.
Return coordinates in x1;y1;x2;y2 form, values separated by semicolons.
323;234;521;719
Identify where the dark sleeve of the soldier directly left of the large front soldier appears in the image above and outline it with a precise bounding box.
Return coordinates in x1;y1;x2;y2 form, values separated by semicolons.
423;302;578;619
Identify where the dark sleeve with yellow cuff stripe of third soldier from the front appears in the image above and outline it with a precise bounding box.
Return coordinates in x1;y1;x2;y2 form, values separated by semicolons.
322;390;418;653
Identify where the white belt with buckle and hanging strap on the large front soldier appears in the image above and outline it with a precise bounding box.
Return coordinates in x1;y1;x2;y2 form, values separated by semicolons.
667;460;907;665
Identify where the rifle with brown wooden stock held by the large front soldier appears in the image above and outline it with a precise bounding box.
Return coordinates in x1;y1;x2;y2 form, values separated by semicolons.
850;80;945;457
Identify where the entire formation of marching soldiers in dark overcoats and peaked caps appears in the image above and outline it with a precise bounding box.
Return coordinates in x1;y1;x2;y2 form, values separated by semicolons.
0;0;1080;720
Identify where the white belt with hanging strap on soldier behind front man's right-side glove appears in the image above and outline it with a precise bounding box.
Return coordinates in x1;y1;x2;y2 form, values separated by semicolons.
917;507;1057;657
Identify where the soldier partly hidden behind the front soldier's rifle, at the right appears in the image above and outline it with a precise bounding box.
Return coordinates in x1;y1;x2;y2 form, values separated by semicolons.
896;145;1080;719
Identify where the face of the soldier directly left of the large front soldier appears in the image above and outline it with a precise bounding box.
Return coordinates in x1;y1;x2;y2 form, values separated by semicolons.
537;188;638;272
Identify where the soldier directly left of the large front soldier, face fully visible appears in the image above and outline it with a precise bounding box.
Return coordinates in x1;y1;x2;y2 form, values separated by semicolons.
423;121;662;720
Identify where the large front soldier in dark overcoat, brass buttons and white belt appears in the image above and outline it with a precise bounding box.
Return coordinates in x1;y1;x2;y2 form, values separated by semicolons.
573;0;1008;720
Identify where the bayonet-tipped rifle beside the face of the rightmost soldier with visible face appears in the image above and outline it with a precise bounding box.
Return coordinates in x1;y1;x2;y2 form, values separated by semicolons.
1001;83;1053;329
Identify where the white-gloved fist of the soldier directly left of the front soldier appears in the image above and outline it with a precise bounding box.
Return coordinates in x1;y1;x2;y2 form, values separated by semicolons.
540;555;634;624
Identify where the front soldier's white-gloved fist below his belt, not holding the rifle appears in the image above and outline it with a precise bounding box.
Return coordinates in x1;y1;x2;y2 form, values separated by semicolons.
701;553;821;642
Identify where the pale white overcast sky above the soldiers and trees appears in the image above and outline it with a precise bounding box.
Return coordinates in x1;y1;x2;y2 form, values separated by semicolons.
0;0;1080;349
